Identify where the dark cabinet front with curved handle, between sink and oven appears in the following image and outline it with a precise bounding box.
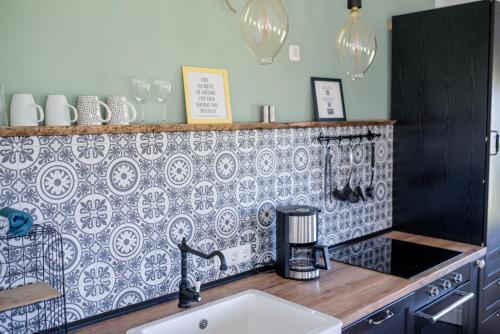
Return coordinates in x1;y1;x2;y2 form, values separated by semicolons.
342;294;415;334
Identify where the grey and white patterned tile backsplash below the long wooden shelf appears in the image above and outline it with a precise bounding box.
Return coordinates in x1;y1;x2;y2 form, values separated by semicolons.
0;126;392;322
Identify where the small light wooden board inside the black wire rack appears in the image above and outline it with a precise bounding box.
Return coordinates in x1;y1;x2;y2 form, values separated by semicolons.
0;283;61;312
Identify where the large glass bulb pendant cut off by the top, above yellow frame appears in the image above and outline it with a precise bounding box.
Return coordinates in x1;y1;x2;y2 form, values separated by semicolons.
240;0;288;65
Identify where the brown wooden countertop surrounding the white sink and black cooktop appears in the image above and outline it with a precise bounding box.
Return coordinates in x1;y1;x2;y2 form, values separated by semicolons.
74;232;486;334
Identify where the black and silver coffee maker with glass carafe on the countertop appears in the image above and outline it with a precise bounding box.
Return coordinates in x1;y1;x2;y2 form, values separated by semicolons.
276;205;330;280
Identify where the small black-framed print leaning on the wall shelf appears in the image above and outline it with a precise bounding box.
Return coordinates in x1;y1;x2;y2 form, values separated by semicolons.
311;78;346;122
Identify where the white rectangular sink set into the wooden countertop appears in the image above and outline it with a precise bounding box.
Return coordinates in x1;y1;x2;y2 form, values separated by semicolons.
127;290;342;334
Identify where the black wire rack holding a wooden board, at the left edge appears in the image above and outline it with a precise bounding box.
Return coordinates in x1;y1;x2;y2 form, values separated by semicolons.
0;225;67;333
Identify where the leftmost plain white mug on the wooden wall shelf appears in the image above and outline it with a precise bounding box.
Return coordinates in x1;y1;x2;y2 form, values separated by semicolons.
10;94;45;126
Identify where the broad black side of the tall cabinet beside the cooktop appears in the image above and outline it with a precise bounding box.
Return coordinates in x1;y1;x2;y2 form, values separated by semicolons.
391;1;491;244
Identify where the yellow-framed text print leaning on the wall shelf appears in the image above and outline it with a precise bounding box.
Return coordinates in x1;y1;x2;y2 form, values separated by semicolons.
182;66;233;124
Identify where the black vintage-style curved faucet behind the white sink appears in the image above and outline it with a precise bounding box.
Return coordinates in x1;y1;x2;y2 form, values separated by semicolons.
177;238;227;308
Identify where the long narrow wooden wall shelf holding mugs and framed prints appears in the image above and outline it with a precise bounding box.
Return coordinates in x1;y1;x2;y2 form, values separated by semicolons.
0;120;396;137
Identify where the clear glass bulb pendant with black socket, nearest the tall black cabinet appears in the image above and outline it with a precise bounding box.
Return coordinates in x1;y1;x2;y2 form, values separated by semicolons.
337;0;377;80
